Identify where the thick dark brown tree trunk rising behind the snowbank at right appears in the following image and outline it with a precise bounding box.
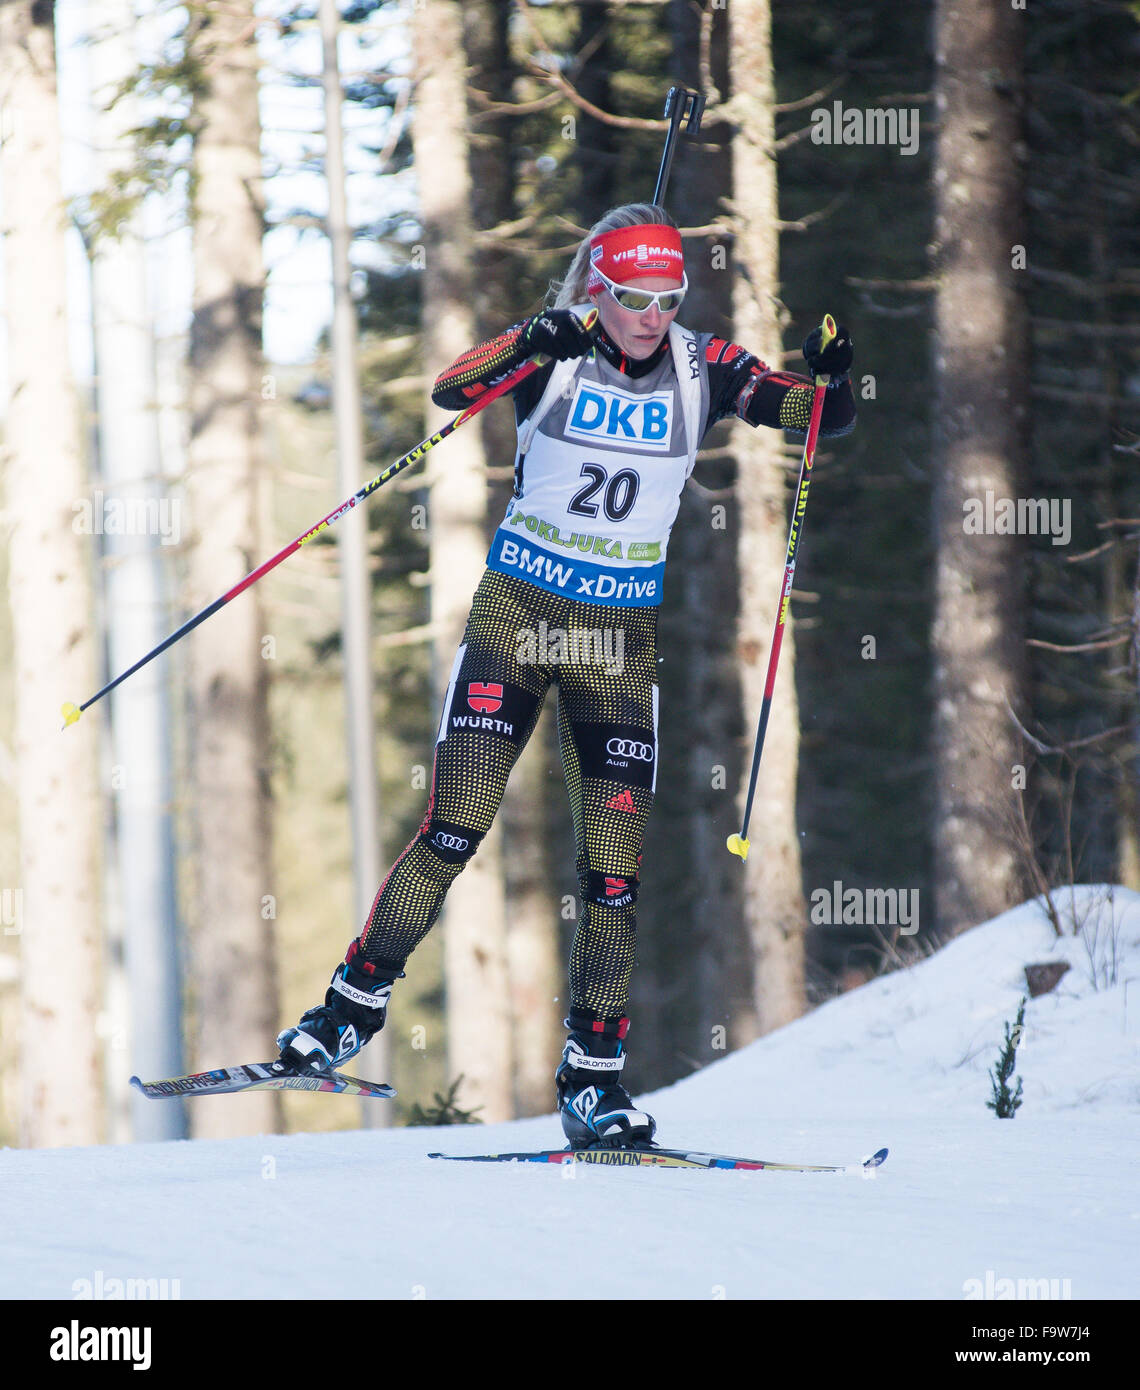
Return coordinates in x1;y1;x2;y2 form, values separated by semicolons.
933;0;1027;935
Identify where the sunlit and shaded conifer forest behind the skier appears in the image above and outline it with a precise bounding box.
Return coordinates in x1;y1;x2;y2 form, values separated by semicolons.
0;0;1140;1144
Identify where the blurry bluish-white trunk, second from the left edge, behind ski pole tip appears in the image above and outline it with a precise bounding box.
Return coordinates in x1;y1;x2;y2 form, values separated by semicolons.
89;0;185;1141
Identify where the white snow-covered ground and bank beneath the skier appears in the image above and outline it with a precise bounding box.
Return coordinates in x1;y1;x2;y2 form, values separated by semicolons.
0;888;1140;1311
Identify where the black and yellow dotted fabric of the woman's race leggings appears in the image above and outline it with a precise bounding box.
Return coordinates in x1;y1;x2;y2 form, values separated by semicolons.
360;570;656;1020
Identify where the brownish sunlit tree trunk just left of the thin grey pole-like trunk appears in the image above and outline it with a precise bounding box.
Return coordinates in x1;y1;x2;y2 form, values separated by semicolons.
188;0;278;1136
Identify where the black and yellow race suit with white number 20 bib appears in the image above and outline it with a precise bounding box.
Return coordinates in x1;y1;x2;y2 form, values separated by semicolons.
355;325;855;1023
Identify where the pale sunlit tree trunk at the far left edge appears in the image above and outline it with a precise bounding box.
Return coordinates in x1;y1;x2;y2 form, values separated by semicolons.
0;0;101;1147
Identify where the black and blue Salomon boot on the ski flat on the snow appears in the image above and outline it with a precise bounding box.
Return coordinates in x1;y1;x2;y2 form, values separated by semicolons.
555;1013;658;1148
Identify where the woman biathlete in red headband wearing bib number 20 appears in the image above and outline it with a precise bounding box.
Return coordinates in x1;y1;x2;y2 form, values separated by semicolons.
278;203;855;1148
